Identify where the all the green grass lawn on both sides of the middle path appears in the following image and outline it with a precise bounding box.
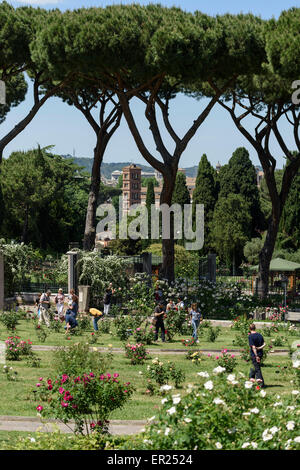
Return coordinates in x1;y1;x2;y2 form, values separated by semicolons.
0;320;300;426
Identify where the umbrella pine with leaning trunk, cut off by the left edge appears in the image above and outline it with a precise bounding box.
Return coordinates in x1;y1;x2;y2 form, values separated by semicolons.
0;2;68;164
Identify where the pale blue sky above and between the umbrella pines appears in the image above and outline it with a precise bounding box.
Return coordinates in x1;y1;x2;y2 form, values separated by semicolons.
0;0;300;167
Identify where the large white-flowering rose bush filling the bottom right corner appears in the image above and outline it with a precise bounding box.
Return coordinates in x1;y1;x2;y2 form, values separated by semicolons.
142;368;300;450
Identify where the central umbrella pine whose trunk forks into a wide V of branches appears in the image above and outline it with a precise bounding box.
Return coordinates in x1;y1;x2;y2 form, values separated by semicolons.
116;11;263;281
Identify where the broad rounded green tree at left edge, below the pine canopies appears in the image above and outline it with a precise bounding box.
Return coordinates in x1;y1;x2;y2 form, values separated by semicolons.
1;148;88;251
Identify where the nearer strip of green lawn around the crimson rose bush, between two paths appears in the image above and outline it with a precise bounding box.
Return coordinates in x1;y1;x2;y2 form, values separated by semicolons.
0;351;293;420
